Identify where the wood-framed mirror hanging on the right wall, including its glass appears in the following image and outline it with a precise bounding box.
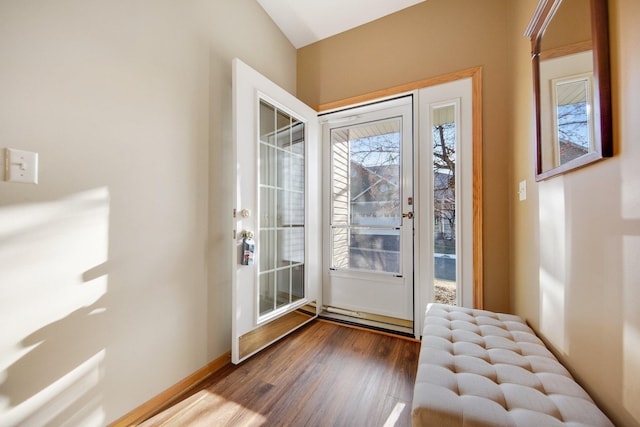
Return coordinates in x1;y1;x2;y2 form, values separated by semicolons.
525;0;613;181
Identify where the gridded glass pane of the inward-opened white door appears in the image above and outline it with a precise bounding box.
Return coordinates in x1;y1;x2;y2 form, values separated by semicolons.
258;100;305;320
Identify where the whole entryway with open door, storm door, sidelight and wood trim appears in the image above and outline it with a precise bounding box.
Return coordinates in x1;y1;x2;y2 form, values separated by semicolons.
231;60;482;363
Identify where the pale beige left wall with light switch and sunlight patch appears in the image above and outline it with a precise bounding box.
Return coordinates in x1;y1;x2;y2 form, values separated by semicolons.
0;0;296;425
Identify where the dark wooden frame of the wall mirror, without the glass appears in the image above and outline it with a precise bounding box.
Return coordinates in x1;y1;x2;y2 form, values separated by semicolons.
525;0;613;181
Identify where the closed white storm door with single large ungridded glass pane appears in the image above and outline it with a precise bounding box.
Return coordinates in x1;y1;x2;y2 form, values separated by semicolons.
321;96;414;329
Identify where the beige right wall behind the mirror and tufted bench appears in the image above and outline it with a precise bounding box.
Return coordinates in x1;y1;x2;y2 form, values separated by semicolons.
509;0;640;426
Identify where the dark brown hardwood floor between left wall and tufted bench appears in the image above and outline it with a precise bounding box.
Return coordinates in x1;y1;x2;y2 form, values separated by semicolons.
140;320;420;427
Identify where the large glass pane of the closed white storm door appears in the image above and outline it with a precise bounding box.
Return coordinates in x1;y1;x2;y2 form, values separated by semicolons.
331;118;402;274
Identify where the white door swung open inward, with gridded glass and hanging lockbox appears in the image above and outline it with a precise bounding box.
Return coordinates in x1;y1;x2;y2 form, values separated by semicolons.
231;59;321;363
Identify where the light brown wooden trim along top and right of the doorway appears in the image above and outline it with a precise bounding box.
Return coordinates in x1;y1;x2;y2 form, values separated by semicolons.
315;67;484;309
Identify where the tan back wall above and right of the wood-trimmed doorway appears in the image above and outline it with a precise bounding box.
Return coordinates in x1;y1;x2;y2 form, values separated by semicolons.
298;0;510;311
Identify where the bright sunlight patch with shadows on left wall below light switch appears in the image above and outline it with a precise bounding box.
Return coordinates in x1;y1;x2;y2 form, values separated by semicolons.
0;188;109;426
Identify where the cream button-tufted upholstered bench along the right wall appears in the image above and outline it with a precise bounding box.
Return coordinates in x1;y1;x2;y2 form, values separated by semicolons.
412;304;613;427
